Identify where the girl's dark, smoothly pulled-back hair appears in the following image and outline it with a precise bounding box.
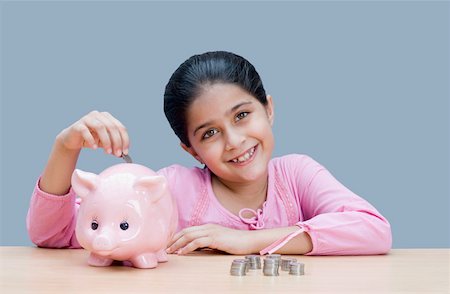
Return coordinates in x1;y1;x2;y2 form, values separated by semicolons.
164;51;267;147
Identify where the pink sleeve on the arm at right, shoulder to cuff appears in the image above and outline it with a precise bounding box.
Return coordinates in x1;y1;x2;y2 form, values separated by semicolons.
290;156;392;255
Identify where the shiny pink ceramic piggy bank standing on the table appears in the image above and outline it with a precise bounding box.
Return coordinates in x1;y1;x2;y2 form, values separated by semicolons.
72;163;178;268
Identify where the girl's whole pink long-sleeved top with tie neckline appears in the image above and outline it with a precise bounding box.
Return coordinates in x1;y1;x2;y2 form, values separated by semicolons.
27;154;392;255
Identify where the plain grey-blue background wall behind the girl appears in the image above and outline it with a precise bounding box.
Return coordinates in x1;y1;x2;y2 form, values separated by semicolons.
0;1;450;248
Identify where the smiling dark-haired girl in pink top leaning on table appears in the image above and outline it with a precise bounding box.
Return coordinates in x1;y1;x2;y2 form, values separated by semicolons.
27;51;391;255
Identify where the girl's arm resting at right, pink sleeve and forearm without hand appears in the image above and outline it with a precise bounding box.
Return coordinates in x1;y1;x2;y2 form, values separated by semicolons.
243;155;392;255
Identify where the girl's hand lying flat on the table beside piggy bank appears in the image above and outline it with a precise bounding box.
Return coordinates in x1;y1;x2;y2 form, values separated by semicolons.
166;224;251;254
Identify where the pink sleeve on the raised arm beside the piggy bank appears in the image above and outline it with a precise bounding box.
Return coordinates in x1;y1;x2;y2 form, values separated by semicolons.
27;179;81;248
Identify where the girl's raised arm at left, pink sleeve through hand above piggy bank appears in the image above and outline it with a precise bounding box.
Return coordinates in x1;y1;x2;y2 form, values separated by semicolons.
27;111;129;248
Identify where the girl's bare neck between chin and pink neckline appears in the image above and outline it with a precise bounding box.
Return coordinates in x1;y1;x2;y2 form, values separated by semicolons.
211;173;268;215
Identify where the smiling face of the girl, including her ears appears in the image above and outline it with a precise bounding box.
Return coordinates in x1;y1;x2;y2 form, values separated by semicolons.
181;84;274;183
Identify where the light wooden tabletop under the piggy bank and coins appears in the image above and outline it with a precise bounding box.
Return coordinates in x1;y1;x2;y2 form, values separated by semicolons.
0;247;450;293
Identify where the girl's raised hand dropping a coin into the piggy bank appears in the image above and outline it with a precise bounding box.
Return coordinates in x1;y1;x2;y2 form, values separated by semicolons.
57;110;130;157
